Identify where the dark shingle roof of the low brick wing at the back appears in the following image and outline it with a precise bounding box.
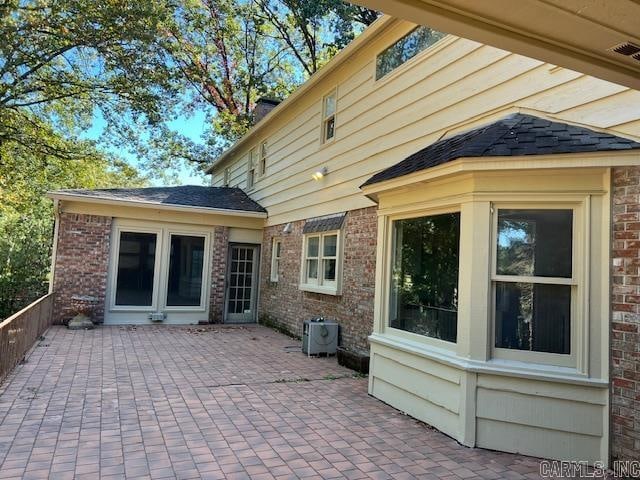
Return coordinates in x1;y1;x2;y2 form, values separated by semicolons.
54;185;266;213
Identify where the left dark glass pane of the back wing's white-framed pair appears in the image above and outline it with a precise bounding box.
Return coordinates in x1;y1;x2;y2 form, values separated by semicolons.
116;232;156;306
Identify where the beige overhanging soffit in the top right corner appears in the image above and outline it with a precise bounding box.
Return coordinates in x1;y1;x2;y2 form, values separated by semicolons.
352;0;640;90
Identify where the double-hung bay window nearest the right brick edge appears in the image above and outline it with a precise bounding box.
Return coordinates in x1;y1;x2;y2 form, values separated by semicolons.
492;207;578;365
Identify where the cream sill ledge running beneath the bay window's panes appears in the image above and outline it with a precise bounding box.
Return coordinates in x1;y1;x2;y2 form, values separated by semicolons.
369;333;609;388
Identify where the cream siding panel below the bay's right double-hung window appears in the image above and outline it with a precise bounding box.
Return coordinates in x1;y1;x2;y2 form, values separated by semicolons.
476;375;608;463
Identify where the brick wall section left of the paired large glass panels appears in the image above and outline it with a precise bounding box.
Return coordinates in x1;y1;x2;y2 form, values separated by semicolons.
53;213;111;323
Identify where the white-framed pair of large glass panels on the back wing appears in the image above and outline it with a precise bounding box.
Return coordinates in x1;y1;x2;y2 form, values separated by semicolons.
105;220;211;324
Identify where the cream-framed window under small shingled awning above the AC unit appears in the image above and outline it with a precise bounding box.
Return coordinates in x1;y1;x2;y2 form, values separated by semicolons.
300;231;340;295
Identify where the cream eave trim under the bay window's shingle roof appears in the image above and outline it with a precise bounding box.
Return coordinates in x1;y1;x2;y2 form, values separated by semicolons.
361;150;640;203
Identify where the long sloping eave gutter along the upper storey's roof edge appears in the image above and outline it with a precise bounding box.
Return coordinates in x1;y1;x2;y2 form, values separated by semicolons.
205;15;397;173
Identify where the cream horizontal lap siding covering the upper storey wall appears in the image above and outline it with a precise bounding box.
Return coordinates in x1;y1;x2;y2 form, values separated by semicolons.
214;20;640;225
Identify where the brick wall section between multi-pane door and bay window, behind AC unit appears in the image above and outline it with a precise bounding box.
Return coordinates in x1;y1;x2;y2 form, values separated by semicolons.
259;207;377;350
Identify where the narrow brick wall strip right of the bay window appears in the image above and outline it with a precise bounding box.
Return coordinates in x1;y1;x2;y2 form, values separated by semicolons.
611;167;640;460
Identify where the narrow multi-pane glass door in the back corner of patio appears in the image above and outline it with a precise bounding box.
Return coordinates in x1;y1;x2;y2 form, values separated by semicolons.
225;245;259;323
